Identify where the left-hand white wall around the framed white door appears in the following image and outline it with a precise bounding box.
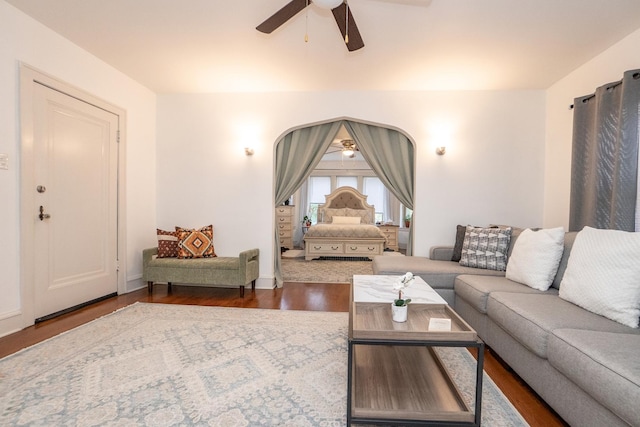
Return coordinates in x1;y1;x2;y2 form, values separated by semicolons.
0;0;156;336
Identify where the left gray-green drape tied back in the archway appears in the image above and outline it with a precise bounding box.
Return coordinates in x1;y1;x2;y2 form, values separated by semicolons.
274;122;341;287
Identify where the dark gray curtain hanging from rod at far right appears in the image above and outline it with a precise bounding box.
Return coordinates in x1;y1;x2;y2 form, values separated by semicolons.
569;70;640;231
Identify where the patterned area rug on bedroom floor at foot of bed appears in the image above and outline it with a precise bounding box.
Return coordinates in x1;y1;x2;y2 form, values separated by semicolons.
281;258;373;283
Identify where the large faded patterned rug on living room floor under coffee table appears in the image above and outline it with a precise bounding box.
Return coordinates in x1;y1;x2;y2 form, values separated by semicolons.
0;303;526;427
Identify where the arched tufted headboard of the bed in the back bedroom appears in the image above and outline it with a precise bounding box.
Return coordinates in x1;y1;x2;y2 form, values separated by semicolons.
318;187;376;224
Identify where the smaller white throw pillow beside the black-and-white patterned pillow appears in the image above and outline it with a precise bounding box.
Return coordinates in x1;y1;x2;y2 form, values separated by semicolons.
505;227;564;291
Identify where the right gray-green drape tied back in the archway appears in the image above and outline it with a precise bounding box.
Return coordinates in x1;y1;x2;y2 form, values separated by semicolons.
343;120;414;255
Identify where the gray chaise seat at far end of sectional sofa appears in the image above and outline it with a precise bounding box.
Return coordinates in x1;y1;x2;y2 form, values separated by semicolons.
372;256;504;290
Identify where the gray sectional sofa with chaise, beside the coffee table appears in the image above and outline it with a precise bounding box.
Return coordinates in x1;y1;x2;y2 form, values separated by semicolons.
373;232;640;426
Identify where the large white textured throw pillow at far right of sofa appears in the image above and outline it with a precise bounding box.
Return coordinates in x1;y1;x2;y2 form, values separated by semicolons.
560;227;640;328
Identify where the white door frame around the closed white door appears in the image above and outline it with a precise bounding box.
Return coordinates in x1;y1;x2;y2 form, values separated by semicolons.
19;63;127;327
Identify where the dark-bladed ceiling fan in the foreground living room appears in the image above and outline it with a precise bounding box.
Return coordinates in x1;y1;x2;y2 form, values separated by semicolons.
256;0;364;52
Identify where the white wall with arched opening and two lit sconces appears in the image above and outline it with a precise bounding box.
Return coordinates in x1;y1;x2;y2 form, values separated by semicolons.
157;91;545;286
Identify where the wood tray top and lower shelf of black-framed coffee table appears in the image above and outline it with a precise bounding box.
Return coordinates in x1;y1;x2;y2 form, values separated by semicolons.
347;276;484;426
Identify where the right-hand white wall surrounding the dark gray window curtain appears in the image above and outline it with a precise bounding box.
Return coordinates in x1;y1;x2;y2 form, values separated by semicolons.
544;30;640;228
